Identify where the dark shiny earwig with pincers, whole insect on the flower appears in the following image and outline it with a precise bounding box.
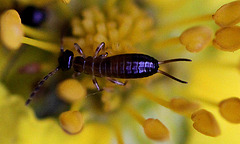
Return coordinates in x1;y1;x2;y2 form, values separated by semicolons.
26;42;191;105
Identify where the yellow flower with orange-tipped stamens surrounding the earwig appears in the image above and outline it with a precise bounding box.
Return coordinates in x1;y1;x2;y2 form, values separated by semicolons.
0;0;240;143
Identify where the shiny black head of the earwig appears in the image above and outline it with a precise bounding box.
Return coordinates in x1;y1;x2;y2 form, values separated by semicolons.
58;50;74;71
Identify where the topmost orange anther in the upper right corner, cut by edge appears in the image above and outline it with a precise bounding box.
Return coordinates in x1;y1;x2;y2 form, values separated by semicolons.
213;1;240;27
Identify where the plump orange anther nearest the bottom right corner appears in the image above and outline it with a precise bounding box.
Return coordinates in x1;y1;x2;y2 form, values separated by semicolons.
191;109;220;137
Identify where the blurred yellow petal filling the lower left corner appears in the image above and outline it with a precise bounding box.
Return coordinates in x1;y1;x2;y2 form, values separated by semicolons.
0;84;112;144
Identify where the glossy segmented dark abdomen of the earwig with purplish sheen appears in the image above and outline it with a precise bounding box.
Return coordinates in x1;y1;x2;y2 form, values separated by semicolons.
94;54;158;79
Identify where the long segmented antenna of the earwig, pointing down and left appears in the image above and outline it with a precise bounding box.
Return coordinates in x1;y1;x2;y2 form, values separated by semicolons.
25;67;59;105
